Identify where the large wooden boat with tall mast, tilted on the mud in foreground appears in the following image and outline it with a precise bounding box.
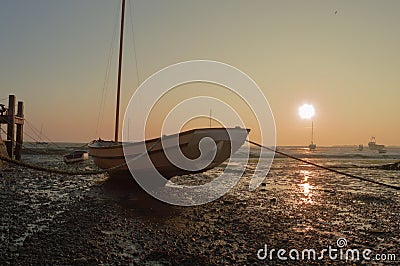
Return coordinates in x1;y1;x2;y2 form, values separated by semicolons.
88;0;250;179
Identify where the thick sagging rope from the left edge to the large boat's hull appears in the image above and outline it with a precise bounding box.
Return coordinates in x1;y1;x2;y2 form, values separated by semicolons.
0;139;161;175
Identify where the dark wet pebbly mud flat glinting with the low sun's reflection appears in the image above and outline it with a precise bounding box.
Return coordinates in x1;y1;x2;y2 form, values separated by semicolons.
0;156;400;265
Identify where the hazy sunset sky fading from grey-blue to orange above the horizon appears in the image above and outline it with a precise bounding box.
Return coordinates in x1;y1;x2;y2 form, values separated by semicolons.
0;0;400;146
